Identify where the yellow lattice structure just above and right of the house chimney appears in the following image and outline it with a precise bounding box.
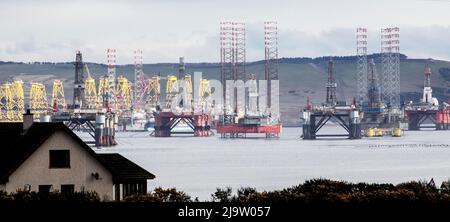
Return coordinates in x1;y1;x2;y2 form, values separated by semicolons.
30;83;49;117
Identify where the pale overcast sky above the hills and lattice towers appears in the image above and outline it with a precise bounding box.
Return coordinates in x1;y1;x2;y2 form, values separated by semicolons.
0;0;450;64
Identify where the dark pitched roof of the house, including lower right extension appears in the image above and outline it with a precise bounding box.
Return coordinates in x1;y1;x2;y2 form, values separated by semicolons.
0;122;155;184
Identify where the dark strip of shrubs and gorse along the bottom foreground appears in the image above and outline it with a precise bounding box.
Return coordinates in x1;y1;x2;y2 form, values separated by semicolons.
4;179;450;204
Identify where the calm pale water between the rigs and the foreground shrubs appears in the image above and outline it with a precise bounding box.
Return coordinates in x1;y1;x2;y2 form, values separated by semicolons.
81;126;450;200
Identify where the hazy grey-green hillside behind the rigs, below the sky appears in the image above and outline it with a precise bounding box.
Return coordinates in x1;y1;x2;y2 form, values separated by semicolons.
0;55;450;125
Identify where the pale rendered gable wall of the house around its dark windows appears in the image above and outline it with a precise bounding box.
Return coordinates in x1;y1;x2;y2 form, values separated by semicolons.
6;131;113;200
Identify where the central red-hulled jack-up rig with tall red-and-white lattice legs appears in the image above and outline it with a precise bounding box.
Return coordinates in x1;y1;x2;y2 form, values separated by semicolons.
215;21;281;138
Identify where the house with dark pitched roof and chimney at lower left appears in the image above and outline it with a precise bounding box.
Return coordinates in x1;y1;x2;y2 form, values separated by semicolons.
0;111;155;201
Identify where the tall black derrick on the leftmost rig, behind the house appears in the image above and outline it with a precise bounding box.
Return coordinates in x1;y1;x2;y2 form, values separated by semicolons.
72;51;84;108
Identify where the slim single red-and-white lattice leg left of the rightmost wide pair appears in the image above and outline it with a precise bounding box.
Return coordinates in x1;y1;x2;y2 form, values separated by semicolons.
356;27;367;105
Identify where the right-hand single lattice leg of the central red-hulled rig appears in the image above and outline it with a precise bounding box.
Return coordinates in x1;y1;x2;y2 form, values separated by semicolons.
264;21;279;118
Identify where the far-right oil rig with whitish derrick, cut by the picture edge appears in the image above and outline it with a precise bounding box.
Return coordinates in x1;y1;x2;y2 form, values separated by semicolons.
405;63;450;130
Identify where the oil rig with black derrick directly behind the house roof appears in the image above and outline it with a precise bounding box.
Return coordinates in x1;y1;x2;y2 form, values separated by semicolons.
50;51;117;146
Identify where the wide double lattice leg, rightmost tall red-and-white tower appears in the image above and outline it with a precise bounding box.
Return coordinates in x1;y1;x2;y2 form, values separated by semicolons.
381;27;400;109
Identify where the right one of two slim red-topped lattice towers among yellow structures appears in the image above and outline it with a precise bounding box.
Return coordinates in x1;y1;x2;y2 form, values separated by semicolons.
133;50;148;110
